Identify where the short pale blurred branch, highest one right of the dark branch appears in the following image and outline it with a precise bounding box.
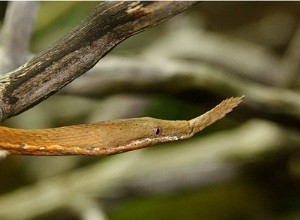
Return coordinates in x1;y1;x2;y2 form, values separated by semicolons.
144;17;280;85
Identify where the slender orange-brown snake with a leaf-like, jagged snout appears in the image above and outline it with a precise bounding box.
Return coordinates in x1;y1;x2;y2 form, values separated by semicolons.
0;97;243;155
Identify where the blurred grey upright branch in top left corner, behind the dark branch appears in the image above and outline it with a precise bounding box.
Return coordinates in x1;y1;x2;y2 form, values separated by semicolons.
0;1;37;74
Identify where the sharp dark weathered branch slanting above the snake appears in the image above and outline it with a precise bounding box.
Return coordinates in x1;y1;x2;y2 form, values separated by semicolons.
0;2;195;120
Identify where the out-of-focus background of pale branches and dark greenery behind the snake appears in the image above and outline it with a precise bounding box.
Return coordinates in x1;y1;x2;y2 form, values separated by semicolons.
0;1;300;219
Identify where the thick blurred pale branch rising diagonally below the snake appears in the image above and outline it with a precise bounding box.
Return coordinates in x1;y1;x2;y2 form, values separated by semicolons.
0;120;300;219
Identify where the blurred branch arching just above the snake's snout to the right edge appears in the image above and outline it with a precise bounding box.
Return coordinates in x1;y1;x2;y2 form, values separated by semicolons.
62;55;300;125
